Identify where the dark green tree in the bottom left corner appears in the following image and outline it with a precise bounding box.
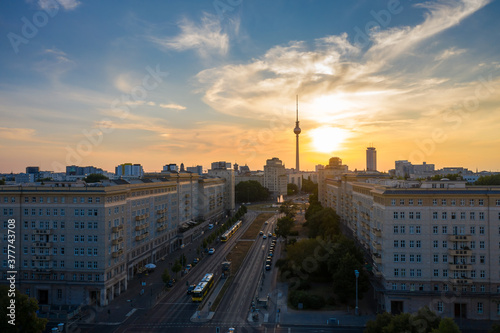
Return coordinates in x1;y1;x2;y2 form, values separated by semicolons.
0;285;47;333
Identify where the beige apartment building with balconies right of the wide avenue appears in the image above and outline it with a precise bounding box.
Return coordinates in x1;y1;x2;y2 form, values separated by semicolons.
322;175;500;320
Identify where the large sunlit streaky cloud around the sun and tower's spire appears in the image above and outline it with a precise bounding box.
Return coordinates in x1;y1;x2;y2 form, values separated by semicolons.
197;0;489;126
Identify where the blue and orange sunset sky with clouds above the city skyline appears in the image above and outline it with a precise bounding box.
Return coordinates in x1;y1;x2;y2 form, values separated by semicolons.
0;0;500;173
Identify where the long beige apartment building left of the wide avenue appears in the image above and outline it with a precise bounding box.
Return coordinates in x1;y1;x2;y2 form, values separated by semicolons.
0;173;225;306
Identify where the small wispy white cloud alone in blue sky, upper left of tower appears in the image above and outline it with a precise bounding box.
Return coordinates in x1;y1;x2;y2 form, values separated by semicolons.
151;13;232;58
